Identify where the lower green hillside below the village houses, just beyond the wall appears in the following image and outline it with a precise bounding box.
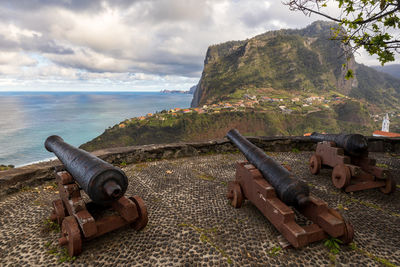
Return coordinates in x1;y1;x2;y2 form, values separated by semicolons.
81;100;376;151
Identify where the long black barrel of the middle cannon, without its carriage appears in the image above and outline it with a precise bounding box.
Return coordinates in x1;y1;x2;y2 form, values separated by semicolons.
227;129;310;207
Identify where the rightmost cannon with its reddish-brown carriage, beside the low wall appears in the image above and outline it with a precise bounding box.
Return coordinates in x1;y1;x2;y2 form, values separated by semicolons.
310;132;396;194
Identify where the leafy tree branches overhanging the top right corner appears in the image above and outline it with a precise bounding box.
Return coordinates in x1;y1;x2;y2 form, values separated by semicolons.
285;0;400;65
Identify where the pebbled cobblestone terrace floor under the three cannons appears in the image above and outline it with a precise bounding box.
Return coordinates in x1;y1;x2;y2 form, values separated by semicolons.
0;152;400;266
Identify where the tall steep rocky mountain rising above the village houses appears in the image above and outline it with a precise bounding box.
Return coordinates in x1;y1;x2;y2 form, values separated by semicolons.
192;21;400;107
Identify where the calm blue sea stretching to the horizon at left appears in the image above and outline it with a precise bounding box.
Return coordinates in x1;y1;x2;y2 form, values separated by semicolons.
0;92;192;167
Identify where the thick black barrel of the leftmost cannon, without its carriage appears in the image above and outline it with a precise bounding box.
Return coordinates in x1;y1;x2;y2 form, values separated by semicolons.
44;135;128;205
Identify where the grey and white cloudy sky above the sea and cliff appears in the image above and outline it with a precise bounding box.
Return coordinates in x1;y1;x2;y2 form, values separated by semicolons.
0;0;386;91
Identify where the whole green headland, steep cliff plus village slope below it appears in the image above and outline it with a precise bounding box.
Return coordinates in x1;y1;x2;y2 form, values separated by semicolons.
81;22;400;151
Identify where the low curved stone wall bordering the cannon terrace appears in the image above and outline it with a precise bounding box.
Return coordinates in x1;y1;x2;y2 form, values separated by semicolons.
0;137;400;196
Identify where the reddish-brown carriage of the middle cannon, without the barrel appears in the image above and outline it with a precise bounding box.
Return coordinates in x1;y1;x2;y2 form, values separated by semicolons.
227;161;354;248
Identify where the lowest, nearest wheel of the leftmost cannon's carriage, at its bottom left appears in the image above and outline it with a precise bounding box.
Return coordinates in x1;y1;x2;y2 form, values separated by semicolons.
59;216;82;257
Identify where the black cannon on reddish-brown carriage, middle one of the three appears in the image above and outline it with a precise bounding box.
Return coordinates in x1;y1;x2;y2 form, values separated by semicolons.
227;129;354;248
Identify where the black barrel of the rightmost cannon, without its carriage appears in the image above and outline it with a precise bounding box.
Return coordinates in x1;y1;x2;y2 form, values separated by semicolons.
310;132;368;156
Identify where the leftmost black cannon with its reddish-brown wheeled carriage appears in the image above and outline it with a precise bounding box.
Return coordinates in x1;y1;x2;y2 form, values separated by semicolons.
45;135;148;256
